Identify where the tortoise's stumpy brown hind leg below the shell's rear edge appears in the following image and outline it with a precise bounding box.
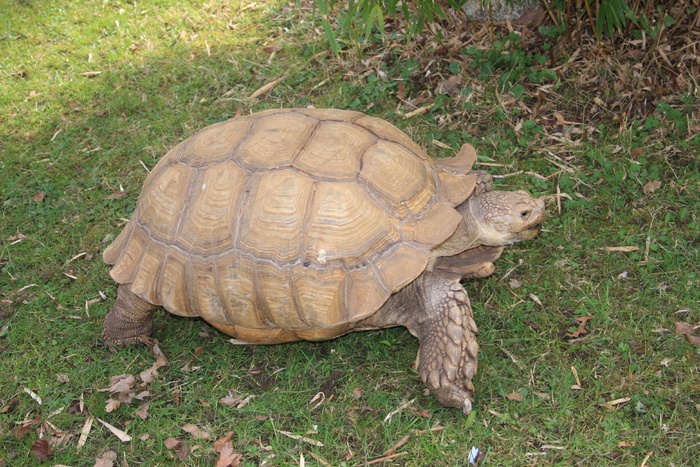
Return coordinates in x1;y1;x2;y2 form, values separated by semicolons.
102;284;158;345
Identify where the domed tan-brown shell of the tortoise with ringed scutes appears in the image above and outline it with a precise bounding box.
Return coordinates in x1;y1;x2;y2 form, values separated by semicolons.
104;109;476;343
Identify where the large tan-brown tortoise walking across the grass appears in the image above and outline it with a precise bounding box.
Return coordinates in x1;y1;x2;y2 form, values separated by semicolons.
103;108;544;414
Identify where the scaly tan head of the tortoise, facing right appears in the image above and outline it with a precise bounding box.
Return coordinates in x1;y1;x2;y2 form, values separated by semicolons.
467;190;545;246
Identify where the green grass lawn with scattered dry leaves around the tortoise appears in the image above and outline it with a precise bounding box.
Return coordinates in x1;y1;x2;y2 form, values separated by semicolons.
0;0;700;466
